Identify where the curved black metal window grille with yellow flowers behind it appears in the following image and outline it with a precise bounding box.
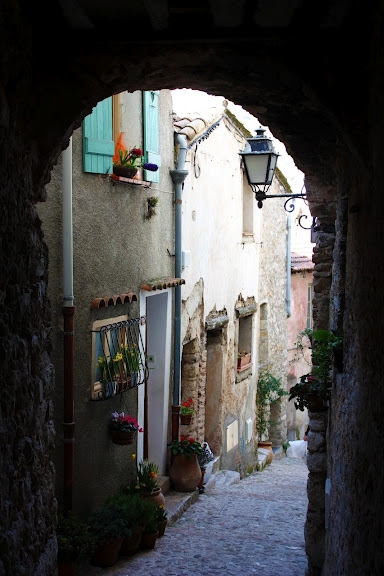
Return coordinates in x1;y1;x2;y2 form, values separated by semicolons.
93;316;149;400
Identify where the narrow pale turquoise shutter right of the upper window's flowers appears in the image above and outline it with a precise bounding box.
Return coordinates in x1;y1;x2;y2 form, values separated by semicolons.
143;90;161;182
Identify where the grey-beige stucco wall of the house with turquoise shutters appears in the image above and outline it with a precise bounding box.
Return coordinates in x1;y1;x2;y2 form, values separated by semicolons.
39;91;174;516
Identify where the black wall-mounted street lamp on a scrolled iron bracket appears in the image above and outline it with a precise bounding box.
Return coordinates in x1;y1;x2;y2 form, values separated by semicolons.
240;126;315;230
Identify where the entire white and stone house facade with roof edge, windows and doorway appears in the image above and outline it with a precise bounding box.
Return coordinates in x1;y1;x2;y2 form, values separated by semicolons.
174;101;287;476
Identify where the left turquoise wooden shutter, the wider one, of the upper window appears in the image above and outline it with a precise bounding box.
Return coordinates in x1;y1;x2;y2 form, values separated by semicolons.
83;96;115;174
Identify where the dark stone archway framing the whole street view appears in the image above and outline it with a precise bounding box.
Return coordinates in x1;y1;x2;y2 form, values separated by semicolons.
0;0;384;576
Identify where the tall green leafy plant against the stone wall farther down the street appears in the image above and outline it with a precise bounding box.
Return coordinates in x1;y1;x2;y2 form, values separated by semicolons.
256;368;288;440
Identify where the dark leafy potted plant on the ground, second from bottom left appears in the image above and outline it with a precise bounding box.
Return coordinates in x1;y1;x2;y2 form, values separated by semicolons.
88;501;131;568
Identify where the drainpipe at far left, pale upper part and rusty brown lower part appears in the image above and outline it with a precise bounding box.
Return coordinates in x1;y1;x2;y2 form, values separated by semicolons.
62;138;75;512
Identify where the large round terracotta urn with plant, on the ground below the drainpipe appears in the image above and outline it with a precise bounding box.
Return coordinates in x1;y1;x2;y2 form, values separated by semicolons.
169;436;203;492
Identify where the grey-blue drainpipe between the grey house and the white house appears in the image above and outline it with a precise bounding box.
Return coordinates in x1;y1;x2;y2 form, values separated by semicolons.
170;134;188;440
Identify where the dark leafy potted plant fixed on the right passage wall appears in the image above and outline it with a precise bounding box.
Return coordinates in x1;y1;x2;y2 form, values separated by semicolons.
289;330;343;412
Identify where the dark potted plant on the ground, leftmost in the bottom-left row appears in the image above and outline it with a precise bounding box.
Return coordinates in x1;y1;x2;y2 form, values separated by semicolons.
56;512;96;576
